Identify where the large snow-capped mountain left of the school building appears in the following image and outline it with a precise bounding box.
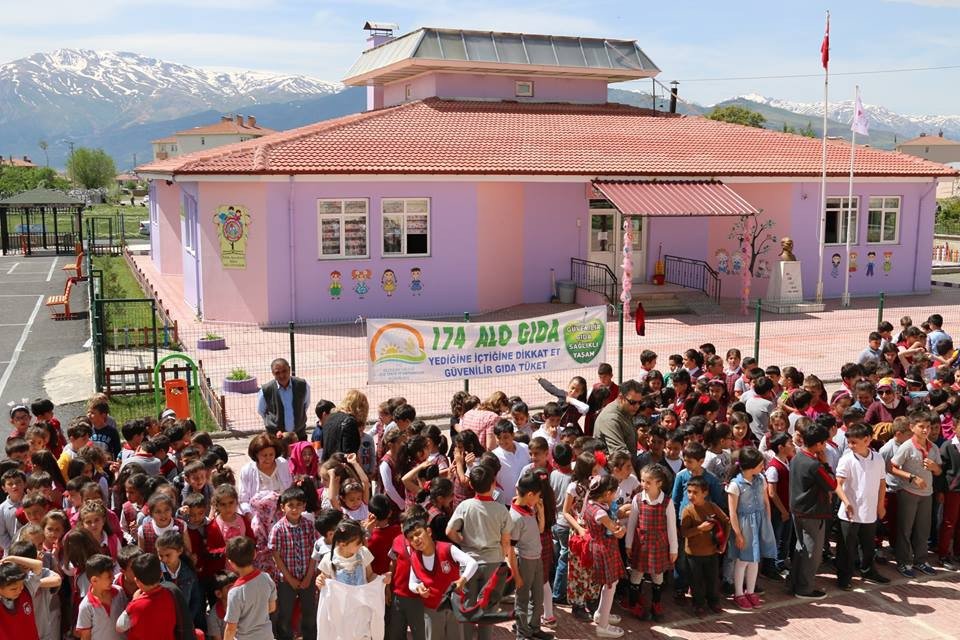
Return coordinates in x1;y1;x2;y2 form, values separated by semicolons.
0;49;342;135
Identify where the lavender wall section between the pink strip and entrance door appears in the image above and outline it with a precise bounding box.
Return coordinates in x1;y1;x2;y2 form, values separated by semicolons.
522;182;589;303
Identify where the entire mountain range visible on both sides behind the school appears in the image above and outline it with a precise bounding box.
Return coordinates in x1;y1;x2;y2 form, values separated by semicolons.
0;49;960;169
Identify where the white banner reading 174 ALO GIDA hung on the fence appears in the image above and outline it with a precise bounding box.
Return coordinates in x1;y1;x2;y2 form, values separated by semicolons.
367;307;607;384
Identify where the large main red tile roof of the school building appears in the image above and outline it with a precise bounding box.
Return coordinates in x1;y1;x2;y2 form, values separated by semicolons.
138;98;957;177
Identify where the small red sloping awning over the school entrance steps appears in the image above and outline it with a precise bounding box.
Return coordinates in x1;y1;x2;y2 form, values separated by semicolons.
593;180;760;217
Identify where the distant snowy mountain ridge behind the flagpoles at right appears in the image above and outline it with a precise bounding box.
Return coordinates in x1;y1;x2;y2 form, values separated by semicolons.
738;94;960;139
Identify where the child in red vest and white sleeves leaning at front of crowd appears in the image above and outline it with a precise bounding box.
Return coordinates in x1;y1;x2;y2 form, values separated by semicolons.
403;518;479;640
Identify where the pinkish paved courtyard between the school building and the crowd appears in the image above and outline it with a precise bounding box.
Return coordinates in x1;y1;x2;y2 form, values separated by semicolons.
129;256;960;431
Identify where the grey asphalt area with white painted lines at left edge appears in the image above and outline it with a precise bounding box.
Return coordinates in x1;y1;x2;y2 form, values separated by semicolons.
0;256;92;406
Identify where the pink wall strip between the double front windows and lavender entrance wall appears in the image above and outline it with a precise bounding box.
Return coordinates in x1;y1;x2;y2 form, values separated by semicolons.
477;182;526;311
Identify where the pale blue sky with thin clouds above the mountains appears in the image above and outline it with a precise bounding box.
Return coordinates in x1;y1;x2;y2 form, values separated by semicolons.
0;0;960;114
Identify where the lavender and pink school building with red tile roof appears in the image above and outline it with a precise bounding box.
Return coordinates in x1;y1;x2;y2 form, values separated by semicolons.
137;25;957;325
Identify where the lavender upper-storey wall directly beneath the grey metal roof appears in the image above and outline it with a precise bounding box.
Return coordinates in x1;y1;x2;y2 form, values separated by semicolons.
383;72;607;106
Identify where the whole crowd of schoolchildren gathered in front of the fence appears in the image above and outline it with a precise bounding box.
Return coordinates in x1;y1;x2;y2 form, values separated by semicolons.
0;315;960;640
